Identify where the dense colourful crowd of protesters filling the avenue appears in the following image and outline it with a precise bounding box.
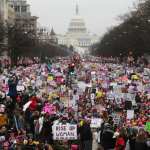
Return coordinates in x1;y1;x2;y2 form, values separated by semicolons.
0;55;150;150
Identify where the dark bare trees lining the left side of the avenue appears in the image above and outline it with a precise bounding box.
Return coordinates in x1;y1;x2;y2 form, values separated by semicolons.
0;23;70;64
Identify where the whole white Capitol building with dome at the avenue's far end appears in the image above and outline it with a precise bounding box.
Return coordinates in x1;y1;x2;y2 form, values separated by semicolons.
57;5;99;53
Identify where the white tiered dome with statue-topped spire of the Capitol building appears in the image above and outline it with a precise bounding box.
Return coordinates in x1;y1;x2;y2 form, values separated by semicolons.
68;5;87;34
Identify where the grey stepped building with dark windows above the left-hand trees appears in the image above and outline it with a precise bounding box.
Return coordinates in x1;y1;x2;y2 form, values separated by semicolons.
9;0;38;34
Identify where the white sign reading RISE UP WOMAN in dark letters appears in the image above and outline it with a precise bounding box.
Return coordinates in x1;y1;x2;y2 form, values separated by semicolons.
53;124;77;140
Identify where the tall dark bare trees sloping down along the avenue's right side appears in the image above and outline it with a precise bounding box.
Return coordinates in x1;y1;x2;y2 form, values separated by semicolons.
91;0;150;56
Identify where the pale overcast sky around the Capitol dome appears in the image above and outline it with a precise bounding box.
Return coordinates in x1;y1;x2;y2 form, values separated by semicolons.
27;0;137;36
